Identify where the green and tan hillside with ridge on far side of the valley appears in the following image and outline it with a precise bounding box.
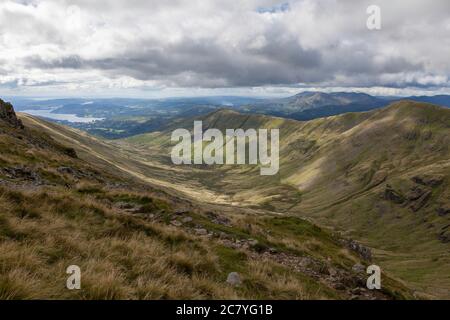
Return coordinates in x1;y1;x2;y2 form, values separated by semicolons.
120;101;450;297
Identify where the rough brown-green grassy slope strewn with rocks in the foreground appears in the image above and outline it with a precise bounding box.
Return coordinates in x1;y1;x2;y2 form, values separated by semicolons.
0;116;411;299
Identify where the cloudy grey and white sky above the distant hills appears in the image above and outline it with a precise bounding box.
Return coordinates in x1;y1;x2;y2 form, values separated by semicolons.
0;0;450;98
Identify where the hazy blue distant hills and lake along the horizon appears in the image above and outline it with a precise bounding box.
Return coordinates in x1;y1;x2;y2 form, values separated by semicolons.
11;92;450;139
